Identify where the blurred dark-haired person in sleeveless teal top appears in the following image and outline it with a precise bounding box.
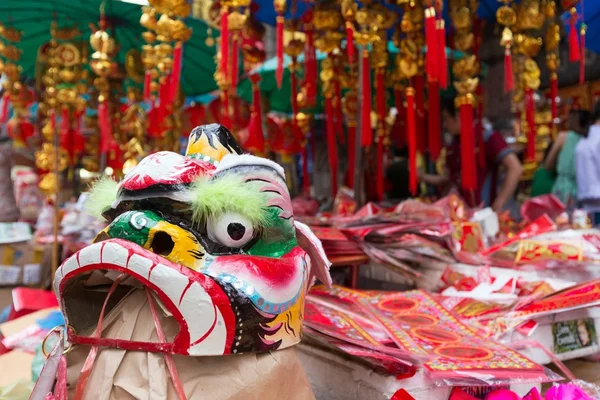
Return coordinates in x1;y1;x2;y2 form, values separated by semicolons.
544;110;591;209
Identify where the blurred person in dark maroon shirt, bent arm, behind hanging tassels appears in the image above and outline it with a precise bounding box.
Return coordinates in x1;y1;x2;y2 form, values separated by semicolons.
419;98;523;212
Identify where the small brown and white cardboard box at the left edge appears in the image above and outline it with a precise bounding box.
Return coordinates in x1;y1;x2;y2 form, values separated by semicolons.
0;242;44;286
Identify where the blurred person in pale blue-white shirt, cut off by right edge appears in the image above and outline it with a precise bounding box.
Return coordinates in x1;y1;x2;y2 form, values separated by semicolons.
575;101;600;226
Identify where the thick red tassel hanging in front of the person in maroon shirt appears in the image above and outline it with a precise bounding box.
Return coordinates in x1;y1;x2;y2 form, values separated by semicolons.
460;103;477;193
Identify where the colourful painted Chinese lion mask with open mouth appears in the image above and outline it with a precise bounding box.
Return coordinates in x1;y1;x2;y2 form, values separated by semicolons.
54;124;330;356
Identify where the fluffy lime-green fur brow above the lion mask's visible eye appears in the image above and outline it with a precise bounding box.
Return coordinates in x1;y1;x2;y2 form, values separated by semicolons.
192;174;269;227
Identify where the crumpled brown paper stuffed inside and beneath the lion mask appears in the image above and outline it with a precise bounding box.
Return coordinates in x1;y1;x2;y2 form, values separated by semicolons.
68;290;314;400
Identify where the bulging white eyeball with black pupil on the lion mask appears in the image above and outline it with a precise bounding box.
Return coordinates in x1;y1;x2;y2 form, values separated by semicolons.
207;212;254;248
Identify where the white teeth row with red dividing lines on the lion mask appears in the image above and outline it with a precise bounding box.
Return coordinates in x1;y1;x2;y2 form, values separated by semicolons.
54;242;227;355
